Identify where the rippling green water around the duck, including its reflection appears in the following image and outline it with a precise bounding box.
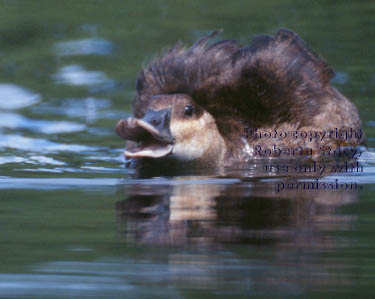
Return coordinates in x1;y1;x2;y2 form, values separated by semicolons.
0;0;375;298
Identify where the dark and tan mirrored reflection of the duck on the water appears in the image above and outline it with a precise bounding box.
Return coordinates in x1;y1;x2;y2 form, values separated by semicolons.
116;176;357;248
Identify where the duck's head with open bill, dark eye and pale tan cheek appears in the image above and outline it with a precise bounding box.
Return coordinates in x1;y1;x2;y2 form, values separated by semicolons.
116;94;226;166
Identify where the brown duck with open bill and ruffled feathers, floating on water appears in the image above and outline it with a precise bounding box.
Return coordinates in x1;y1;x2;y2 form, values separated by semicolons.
115;29;365;169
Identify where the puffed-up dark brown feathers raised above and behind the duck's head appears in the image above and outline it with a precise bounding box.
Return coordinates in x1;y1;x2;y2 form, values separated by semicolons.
134;29;334;124
